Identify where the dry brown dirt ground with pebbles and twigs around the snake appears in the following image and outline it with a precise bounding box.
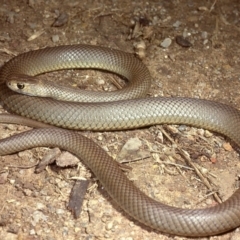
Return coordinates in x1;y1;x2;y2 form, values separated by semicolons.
0;0;240;240
